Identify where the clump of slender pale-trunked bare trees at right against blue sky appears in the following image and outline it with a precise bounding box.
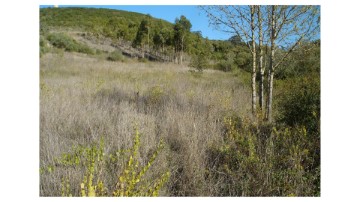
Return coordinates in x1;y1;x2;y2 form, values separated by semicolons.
200;5;320;121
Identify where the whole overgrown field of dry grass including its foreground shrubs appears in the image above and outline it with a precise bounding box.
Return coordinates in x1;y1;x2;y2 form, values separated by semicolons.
40;52;320;196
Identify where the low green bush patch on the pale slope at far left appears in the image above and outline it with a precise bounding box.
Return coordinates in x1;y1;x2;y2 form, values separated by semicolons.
47;33;94;54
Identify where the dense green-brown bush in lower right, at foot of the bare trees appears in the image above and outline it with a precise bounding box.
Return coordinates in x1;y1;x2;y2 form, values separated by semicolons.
206;115;320;196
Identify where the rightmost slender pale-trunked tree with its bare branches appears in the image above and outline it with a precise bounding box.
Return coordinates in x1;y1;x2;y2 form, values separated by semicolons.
267;5;320;122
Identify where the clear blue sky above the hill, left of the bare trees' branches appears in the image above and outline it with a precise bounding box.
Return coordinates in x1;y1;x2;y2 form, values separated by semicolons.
40;5;230;40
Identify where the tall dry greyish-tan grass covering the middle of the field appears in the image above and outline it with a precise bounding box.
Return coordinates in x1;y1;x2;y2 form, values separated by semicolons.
40;53;251;196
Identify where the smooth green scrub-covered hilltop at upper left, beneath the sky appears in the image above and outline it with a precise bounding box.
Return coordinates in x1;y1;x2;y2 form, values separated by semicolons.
40;8;172;41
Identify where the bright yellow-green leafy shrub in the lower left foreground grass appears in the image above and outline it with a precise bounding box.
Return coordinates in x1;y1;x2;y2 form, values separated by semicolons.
40;130;170;196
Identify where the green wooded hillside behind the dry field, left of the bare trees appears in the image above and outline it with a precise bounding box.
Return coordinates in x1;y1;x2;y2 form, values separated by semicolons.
40;8;250;71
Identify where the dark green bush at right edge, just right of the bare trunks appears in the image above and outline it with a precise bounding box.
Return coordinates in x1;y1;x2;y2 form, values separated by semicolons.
276;73;320;178
